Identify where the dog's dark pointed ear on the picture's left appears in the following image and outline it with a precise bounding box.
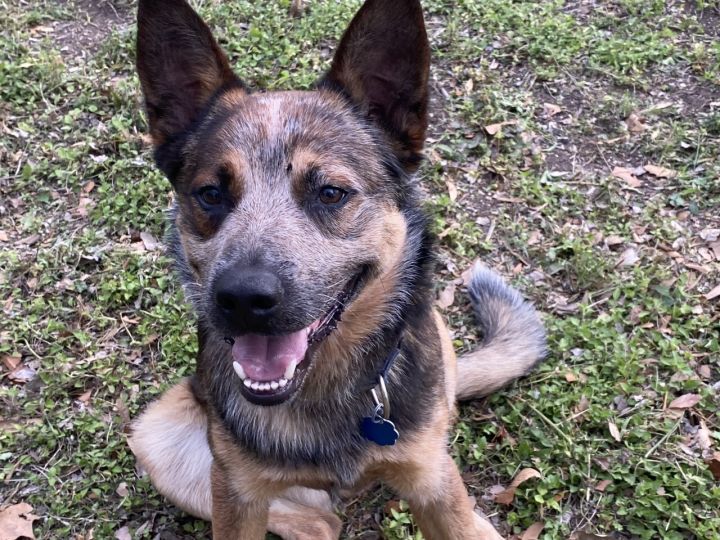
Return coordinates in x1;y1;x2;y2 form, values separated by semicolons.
137;0;242;145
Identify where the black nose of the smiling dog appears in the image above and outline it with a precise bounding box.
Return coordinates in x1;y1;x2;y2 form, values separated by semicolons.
215;266;284;330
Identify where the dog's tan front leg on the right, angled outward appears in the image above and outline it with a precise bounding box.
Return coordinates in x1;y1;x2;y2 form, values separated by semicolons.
386;451;503;540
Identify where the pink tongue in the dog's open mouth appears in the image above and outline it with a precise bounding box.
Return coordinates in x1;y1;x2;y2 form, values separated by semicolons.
232;328;309;381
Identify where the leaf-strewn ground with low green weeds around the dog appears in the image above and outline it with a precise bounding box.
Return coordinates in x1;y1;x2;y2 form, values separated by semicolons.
0;0;720;540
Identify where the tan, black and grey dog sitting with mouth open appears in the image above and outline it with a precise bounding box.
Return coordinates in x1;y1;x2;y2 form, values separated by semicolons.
129;0;545;540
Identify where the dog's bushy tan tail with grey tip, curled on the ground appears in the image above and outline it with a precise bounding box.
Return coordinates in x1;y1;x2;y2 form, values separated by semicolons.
456;264;547;400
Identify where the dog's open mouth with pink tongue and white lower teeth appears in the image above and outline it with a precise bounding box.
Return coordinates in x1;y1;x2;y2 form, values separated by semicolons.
228;267;368;405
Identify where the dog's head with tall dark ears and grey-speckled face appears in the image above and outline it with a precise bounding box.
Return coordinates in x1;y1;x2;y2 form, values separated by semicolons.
137;0;429;404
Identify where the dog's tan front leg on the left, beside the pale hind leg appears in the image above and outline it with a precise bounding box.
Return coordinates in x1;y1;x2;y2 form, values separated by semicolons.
211;463;270;540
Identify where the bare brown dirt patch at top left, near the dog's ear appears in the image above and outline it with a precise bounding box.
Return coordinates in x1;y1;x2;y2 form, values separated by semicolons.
52;0;133;61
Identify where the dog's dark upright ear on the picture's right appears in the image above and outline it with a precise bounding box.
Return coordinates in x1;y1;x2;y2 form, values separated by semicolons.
319;0;430;171
